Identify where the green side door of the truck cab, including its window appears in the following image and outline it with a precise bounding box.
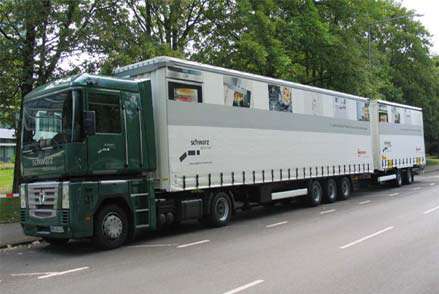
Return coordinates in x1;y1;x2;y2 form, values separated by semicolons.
87;89;126;174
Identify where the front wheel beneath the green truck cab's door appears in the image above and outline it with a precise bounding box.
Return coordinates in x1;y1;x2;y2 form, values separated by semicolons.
93;204;128;250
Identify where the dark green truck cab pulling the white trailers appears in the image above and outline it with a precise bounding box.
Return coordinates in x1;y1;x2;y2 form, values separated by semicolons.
20;74;156;248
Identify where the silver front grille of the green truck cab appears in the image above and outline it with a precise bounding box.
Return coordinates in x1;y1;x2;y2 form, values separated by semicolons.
28;182;59;218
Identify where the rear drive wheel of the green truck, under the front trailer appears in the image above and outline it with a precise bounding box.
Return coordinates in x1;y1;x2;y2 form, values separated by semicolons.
206;192;232;227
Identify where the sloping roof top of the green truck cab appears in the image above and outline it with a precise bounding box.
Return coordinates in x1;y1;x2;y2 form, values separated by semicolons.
24;73;139;101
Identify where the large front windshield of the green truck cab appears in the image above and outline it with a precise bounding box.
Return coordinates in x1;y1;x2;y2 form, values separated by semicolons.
23;90;80;151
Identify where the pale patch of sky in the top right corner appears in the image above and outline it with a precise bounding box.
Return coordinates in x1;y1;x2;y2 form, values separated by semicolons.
400;0;439;55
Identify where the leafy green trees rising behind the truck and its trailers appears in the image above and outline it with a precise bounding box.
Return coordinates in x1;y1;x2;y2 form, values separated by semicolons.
0;0;439;167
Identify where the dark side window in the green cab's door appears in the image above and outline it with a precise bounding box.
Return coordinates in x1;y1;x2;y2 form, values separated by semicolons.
88;93;121;133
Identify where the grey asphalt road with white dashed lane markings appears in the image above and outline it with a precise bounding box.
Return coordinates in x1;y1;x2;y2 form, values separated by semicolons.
0;173;439;294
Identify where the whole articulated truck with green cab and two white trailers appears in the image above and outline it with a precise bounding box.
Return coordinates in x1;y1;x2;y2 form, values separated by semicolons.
20;57;425;249
